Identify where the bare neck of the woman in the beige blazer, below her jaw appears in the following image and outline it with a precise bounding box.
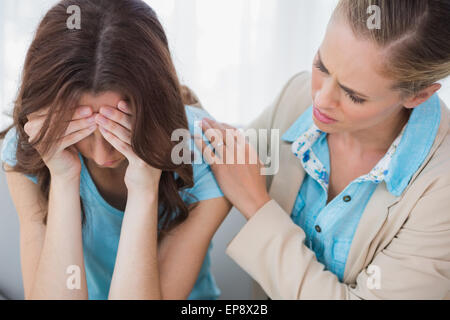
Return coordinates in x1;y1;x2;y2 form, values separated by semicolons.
334;107;411;154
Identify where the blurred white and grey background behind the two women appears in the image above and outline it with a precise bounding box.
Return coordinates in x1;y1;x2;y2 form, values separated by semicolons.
0;0;450;299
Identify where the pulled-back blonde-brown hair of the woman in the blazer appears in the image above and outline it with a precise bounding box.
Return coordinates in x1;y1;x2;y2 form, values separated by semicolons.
333;0;450;95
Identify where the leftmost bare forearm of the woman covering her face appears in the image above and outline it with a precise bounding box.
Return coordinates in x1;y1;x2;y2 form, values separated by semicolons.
30;178;88;299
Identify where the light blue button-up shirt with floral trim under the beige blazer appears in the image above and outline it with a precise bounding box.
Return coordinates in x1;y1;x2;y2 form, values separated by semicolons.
282;94;441;281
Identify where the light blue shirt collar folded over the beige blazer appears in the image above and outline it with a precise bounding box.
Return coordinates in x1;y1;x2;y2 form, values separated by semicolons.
282;94;441;196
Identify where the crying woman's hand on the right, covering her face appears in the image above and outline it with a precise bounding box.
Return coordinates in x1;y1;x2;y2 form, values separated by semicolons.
95;101;162;195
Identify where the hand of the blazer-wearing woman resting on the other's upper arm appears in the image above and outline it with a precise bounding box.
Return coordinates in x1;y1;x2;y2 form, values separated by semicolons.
195;119;270;219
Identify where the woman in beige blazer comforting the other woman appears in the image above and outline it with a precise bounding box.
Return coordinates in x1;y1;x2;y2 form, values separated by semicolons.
199;0;450;299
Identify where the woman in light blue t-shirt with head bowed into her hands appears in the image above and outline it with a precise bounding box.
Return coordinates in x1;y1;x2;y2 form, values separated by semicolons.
0;0;230;299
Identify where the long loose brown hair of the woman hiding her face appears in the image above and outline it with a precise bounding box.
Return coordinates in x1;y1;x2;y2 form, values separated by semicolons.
0;0;196;239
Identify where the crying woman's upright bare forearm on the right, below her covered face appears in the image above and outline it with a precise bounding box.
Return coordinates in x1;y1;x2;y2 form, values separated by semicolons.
109;191;161;300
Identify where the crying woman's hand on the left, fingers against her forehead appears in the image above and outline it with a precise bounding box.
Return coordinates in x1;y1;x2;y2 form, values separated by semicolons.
24;107;97;179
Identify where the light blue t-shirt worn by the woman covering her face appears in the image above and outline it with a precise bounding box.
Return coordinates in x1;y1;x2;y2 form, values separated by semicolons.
1;106;223;300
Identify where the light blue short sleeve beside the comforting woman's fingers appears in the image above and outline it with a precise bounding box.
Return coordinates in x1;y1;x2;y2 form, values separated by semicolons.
182;106;224;204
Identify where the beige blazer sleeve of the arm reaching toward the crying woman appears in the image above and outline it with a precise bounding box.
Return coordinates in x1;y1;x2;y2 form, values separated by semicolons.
226;180;450;300
